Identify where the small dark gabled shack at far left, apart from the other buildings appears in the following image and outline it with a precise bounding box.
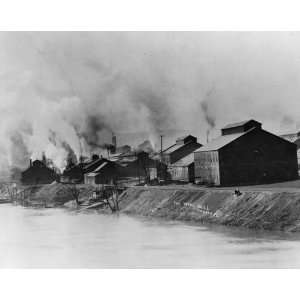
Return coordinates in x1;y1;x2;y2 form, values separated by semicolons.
21;160;58;185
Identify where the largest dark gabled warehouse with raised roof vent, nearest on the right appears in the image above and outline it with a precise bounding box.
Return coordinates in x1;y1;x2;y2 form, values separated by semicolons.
195;120;298;186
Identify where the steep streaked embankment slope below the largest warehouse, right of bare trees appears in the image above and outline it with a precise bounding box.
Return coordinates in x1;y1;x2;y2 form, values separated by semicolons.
120;187;300;231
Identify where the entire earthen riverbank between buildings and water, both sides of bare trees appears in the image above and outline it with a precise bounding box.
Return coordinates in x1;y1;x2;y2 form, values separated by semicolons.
11;181;300;232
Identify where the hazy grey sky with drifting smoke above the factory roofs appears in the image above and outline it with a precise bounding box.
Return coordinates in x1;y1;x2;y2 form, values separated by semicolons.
0;32;300;169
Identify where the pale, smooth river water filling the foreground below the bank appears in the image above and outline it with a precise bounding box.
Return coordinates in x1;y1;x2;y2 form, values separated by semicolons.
0;204;300;268
